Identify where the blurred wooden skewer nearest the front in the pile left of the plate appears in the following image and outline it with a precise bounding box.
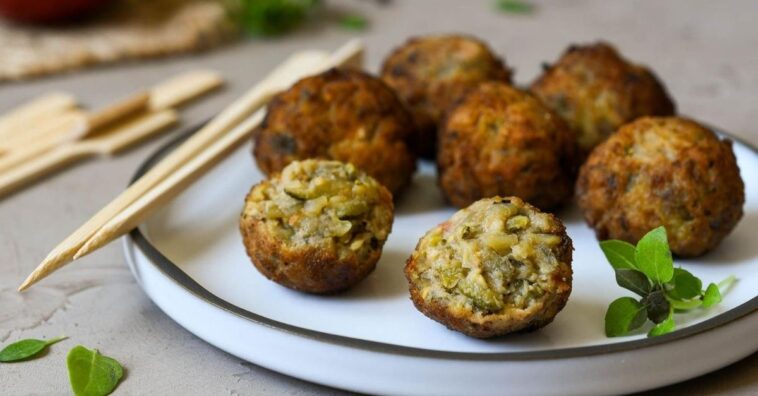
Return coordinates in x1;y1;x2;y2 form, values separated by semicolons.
0;109;179;200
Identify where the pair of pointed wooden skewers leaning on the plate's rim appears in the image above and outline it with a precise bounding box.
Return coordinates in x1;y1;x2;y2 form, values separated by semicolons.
19;40;363;291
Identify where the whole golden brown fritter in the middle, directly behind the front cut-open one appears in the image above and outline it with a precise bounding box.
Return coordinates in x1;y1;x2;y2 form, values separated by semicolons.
437;82;576;210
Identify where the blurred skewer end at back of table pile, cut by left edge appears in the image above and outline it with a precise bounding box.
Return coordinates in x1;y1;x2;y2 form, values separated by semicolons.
0;92;76;141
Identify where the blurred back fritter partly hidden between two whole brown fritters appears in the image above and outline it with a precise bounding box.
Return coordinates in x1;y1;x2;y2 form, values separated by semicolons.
382;35;511;158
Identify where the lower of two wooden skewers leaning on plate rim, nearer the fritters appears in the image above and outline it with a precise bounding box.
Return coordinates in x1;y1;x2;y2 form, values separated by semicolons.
74;41;362;260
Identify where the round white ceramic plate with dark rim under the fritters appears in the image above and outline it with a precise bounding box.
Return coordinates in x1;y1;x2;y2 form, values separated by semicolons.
125;127;758;395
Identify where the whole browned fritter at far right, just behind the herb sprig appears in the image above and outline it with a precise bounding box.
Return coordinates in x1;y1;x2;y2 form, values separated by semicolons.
576;117;745;256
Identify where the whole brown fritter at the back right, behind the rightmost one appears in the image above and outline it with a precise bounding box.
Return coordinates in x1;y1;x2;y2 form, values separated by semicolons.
531;42;675;156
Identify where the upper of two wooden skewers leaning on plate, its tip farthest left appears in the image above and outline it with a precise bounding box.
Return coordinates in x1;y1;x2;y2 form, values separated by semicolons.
19;42;362;291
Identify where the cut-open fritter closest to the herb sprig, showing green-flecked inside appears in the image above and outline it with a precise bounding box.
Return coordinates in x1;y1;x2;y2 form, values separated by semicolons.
405;197;573;338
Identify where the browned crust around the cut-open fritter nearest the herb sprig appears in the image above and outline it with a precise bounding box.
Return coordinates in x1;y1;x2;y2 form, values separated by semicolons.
405;197;573;338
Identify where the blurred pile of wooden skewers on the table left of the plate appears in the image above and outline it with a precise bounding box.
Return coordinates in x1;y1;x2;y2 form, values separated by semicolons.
0;70;222;197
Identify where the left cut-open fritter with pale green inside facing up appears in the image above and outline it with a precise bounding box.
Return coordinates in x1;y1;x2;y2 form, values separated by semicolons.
240;160;393;293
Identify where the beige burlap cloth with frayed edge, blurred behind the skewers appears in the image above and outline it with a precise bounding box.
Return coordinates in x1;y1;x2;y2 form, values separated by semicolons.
0;0;237;81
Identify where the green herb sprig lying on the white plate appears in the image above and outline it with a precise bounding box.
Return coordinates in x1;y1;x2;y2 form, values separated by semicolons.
600;226;736;337
